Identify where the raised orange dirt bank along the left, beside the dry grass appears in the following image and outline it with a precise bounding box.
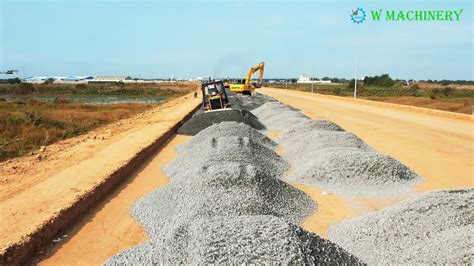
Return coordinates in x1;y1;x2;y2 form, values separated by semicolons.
0;95;200;264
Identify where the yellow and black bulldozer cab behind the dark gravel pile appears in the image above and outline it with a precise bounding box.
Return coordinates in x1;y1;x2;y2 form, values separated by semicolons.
201;80;229;111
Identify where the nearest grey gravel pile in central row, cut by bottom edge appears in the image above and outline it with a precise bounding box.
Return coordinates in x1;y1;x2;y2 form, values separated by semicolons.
106;215;361;265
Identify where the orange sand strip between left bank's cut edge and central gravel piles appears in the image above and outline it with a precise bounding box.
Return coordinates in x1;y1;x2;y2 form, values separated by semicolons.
39;135;191;265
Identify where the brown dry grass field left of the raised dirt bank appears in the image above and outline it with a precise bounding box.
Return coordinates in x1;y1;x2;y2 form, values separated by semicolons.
0;99;154;161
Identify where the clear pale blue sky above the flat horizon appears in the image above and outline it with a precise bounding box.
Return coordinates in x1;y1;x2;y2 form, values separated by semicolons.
0;0;473;80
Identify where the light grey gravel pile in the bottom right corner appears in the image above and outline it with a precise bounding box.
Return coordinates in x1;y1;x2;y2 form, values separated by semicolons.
329;189;474;265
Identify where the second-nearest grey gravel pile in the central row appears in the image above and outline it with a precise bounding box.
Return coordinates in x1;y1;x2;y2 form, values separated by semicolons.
132;162;315;236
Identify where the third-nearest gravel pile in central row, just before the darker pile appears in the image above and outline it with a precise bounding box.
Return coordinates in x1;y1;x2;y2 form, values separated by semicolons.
163;136;290;179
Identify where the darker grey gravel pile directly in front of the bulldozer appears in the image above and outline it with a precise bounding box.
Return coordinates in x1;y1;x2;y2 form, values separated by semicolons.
178;108;265;136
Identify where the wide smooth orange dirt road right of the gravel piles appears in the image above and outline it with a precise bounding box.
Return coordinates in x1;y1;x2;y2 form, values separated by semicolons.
259;88;474;191
